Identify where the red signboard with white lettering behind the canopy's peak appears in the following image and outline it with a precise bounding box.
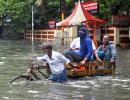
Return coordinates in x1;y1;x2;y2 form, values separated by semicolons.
82;1;98;14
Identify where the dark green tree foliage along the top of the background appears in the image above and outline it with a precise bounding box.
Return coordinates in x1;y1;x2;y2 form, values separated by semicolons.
0;0;130;33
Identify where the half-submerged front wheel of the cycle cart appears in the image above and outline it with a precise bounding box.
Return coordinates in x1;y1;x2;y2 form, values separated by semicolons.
10;75;33;84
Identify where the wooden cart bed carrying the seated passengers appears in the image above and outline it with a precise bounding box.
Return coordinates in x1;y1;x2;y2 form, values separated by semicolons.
65;61;115;78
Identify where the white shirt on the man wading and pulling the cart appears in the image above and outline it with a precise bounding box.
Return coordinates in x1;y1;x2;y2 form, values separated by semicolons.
37;51;70;74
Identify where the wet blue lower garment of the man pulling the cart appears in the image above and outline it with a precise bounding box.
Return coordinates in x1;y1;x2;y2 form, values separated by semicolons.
49;69;67;82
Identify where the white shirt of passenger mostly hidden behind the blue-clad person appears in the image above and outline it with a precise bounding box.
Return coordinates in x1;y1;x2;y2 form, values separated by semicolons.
70;37;96;50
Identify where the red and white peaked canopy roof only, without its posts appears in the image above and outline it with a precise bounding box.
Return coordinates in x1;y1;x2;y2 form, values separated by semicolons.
56;0;106;26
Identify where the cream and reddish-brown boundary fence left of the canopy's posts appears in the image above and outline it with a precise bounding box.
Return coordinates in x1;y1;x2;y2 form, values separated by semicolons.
25;30;75;46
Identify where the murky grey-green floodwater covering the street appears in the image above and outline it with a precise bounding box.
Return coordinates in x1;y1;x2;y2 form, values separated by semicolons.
0;40;130;100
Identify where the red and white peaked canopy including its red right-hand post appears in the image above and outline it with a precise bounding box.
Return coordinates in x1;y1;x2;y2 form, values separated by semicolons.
56;0;106;45
